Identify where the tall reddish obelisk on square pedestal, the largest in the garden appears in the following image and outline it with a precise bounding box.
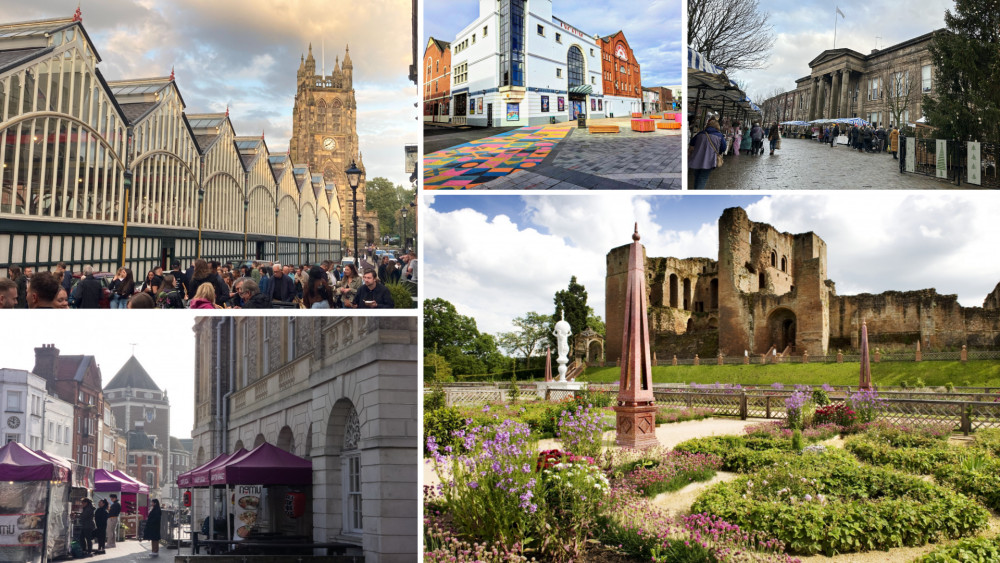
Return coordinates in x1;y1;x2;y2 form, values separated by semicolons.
615;223;658;448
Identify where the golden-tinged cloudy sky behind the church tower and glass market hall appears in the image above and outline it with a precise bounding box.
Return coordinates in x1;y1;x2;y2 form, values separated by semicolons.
6;0;420;187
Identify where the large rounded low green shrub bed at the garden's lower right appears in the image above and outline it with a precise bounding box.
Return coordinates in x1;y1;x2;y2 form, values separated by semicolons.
691;452;989;555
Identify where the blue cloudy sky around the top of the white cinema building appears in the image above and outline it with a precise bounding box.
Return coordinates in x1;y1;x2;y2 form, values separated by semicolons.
426;0;683;87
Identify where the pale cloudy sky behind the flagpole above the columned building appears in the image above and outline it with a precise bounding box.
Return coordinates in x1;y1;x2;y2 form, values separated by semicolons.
731;0;954;102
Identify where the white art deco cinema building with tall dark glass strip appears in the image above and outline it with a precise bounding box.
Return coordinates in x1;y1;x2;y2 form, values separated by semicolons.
451;0;607;127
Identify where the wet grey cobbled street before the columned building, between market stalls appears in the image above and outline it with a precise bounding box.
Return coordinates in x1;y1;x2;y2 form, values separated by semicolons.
700;139;968;190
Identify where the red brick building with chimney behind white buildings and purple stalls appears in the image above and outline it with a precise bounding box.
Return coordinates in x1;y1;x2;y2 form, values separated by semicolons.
31;344;104;468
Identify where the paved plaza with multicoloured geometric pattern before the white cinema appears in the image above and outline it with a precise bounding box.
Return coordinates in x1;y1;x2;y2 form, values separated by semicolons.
424;118;681;190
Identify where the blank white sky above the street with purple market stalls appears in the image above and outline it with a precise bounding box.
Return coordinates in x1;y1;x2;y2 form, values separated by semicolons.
0;310;194;438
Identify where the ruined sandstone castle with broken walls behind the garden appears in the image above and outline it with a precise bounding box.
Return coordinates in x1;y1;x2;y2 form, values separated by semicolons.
605;207;1000;362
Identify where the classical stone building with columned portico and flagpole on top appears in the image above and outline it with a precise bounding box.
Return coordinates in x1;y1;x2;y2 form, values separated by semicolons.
760;29;947;129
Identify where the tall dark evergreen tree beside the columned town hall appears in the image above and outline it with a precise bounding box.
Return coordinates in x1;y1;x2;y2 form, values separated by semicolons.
923;0;1000;143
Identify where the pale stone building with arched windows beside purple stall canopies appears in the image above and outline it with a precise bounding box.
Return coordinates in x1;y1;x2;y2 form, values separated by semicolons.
192;317;419;562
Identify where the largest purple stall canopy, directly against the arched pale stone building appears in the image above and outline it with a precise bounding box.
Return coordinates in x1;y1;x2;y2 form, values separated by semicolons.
211;442;312;485
